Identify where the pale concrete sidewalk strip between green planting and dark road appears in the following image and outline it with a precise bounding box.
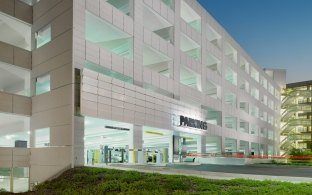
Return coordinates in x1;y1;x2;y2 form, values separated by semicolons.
91;164;312;183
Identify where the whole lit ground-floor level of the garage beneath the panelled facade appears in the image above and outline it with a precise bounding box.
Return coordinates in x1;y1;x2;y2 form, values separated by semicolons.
84;117;273;166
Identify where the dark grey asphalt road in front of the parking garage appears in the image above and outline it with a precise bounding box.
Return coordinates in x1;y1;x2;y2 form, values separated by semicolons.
168;164;312;178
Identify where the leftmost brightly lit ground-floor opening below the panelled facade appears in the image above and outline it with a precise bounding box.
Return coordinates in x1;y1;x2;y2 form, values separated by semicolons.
84;117;132;166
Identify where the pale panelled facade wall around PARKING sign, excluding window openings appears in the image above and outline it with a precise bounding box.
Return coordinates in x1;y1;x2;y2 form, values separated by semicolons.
74;0;280;163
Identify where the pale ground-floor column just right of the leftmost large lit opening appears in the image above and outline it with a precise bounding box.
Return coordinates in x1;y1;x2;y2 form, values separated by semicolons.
129;125;144;163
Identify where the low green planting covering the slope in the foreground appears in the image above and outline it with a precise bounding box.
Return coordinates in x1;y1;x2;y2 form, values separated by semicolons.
6;167;312;195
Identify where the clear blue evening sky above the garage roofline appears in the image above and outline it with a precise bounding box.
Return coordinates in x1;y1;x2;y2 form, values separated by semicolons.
198;0;312;83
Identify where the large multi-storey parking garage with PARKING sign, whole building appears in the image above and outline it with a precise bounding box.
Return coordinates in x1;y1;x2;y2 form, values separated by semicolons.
0;0;281;192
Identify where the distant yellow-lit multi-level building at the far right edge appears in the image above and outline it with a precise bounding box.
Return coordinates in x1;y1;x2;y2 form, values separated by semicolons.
281;81;312;155
